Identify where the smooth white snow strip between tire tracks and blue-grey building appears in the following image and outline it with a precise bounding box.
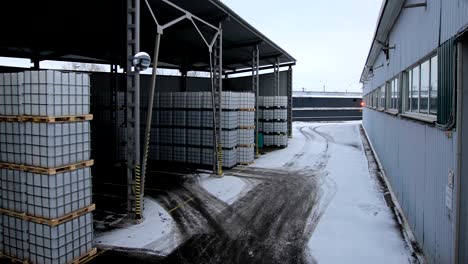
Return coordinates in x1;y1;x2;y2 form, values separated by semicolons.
309;123;411;264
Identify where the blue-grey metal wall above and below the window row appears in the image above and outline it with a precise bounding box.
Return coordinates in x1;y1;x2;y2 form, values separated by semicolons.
363;0;468;263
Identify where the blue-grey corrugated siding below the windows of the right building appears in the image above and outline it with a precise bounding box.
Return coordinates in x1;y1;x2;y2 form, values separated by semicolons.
363;109;456;264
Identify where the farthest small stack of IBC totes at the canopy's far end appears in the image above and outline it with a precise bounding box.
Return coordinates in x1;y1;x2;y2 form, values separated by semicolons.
258;96;288;147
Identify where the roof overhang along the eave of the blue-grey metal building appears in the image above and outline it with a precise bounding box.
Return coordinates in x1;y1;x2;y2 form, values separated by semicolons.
360;0;406;82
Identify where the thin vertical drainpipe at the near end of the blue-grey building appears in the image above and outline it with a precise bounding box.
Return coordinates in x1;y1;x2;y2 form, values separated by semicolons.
453;42;463;264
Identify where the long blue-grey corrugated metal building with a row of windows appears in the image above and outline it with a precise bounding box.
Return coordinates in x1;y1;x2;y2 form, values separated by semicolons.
361;0;468;263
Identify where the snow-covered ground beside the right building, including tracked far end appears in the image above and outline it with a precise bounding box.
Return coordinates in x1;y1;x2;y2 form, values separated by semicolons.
252;122;411;264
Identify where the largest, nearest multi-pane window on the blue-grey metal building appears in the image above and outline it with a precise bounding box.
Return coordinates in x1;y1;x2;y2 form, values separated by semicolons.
406;56;438;115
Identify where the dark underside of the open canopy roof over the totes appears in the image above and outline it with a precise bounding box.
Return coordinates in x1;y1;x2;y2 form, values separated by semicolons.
0;0;295;71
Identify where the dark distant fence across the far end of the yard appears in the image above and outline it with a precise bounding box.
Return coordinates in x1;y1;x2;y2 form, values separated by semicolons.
293;96;362;121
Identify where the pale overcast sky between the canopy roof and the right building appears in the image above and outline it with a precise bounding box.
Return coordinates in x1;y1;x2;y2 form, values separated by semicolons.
223;0;382;92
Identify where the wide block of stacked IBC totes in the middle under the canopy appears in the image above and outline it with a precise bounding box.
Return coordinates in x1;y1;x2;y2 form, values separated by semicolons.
146;92;254;168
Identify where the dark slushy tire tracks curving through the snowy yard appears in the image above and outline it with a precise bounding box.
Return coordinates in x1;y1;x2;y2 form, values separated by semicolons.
129;122;335;264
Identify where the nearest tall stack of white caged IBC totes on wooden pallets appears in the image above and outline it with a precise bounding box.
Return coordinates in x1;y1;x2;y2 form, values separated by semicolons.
0;71;96;263
